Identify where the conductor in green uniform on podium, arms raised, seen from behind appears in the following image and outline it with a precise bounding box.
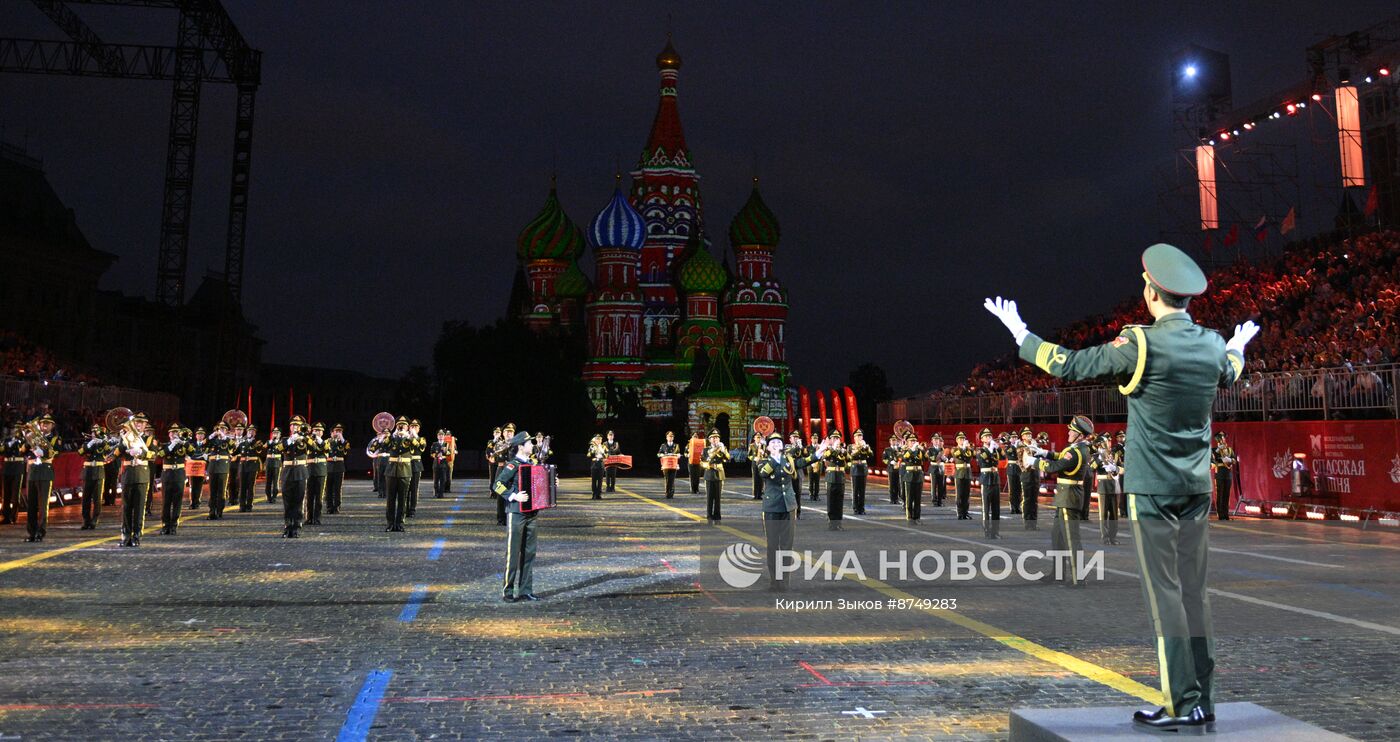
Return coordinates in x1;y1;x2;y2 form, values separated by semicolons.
986;245;1259;732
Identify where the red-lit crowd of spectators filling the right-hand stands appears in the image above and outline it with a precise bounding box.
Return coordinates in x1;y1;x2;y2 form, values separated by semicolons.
935;231;1400;411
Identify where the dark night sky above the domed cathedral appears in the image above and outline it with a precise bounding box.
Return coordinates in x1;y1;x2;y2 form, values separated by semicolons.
0;0;1394;395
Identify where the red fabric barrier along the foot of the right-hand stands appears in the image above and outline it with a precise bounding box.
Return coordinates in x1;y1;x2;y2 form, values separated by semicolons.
871;420;1400;512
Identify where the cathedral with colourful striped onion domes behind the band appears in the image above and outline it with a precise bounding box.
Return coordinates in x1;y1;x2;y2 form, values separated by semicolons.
515;39;794;445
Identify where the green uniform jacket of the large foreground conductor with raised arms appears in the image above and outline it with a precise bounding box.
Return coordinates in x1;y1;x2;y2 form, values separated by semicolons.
1021;312;1245;494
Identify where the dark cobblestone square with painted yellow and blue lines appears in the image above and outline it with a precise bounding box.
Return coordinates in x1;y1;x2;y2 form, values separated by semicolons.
0;476;1400;741
